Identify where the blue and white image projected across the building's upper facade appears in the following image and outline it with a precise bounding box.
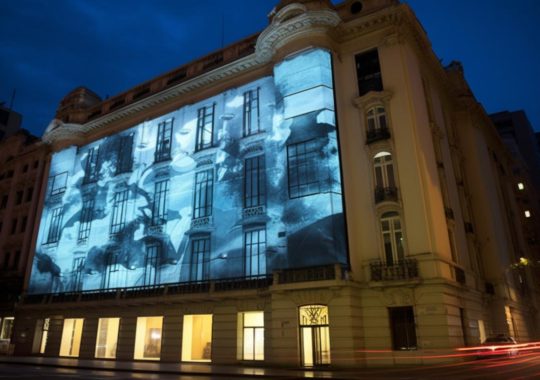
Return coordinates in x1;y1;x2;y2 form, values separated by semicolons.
29;49;347;293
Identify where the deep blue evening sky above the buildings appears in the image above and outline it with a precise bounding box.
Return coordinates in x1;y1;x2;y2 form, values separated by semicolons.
0;0;540;135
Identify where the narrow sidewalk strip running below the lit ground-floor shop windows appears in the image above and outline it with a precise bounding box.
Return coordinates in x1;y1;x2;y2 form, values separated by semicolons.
0;356;358;379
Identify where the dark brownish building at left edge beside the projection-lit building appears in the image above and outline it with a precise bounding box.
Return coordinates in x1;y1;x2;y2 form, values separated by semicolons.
0;129;48;352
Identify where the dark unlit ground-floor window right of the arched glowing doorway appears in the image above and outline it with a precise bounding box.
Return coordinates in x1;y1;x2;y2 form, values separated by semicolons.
388;306;416;350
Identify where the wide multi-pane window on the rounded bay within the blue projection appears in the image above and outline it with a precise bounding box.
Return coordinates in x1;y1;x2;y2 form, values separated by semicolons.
287;140;320;198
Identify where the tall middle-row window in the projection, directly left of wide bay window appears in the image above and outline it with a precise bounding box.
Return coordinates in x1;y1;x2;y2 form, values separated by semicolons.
244;156;266;208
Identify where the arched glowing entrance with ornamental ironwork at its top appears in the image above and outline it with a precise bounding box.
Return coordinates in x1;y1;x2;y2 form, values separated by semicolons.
298;305;330;367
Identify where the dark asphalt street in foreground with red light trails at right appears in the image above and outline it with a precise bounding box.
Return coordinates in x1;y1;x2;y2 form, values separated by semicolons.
0;353;540;380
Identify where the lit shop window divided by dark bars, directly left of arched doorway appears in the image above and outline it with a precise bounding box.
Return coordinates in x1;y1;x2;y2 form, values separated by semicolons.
238;311;264;360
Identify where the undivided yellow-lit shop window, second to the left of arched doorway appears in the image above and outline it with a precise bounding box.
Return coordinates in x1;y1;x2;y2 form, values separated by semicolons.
182;314;212;362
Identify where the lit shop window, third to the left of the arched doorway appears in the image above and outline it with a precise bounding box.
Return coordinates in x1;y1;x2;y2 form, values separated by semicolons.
133;317;163;360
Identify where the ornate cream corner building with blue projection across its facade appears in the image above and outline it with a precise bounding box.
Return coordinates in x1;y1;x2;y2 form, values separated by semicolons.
9;0;540;367
